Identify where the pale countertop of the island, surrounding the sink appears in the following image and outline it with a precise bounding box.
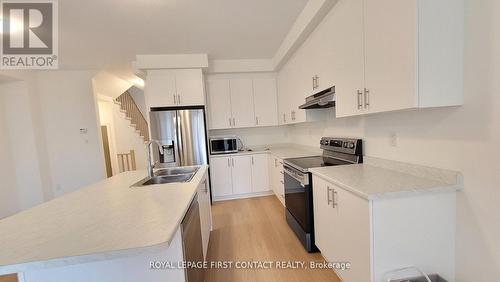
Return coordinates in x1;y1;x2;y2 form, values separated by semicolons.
0;166;208;274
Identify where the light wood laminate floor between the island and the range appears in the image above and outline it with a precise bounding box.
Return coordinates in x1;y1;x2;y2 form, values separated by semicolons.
206;196;340;282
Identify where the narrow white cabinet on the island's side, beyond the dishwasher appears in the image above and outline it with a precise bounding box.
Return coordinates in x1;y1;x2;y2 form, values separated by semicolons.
198;174;212;260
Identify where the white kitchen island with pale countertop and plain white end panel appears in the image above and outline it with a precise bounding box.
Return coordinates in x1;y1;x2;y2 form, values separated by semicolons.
0;166;211;282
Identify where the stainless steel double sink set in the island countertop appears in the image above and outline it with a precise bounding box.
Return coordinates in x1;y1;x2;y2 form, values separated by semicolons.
132;167;199;187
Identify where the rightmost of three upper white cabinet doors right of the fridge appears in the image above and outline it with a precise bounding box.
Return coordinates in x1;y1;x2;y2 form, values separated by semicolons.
253;78;278;126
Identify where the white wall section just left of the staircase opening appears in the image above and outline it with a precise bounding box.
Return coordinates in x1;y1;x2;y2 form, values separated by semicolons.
37;71;105;196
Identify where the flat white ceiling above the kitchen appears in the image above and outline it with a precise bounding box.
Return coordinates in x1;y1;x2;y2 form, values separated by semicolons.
59;0;307;69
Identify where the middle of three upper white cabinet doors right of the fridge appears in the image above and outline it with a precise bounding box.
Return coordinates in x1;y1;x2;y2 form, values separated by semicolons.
230;79;255;127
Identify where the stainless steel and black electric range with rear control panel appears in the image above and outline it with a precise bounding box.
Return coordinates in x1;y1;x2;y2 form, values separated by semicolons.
284;137;363;252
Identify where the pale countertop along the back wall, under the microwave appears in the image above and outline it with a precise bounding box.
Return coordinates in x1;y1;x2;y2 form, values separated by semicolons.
210;144;321;159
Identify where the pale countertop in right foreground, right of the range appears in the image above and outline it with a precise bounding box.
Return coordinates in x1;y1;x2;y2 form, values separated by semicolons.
310;158;462;200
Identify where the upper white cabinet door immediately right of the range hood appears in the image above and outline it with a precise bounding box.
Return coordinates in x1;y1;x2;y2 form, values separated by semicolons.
330;0;365;117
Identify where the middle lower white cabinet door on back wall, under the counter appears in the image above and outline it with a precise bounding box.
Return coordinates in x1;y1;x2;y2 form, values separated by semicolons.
231;155;252;195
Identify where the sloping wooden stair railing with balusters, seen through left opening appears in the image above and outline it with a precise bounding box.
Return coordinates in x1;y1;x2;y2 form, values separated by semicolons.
115;91;149;142
